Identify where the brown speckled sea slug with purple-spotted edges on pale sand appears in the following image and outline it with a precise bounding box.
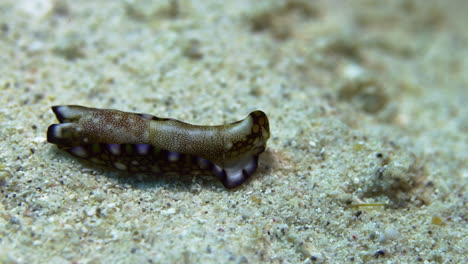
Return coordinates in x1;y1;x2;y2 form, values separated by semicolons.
47;105;270;188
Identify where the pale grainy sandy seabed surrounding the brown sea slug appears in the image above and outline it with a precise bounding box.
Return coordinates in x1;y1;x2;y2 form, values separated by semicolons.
0;0;468;264
